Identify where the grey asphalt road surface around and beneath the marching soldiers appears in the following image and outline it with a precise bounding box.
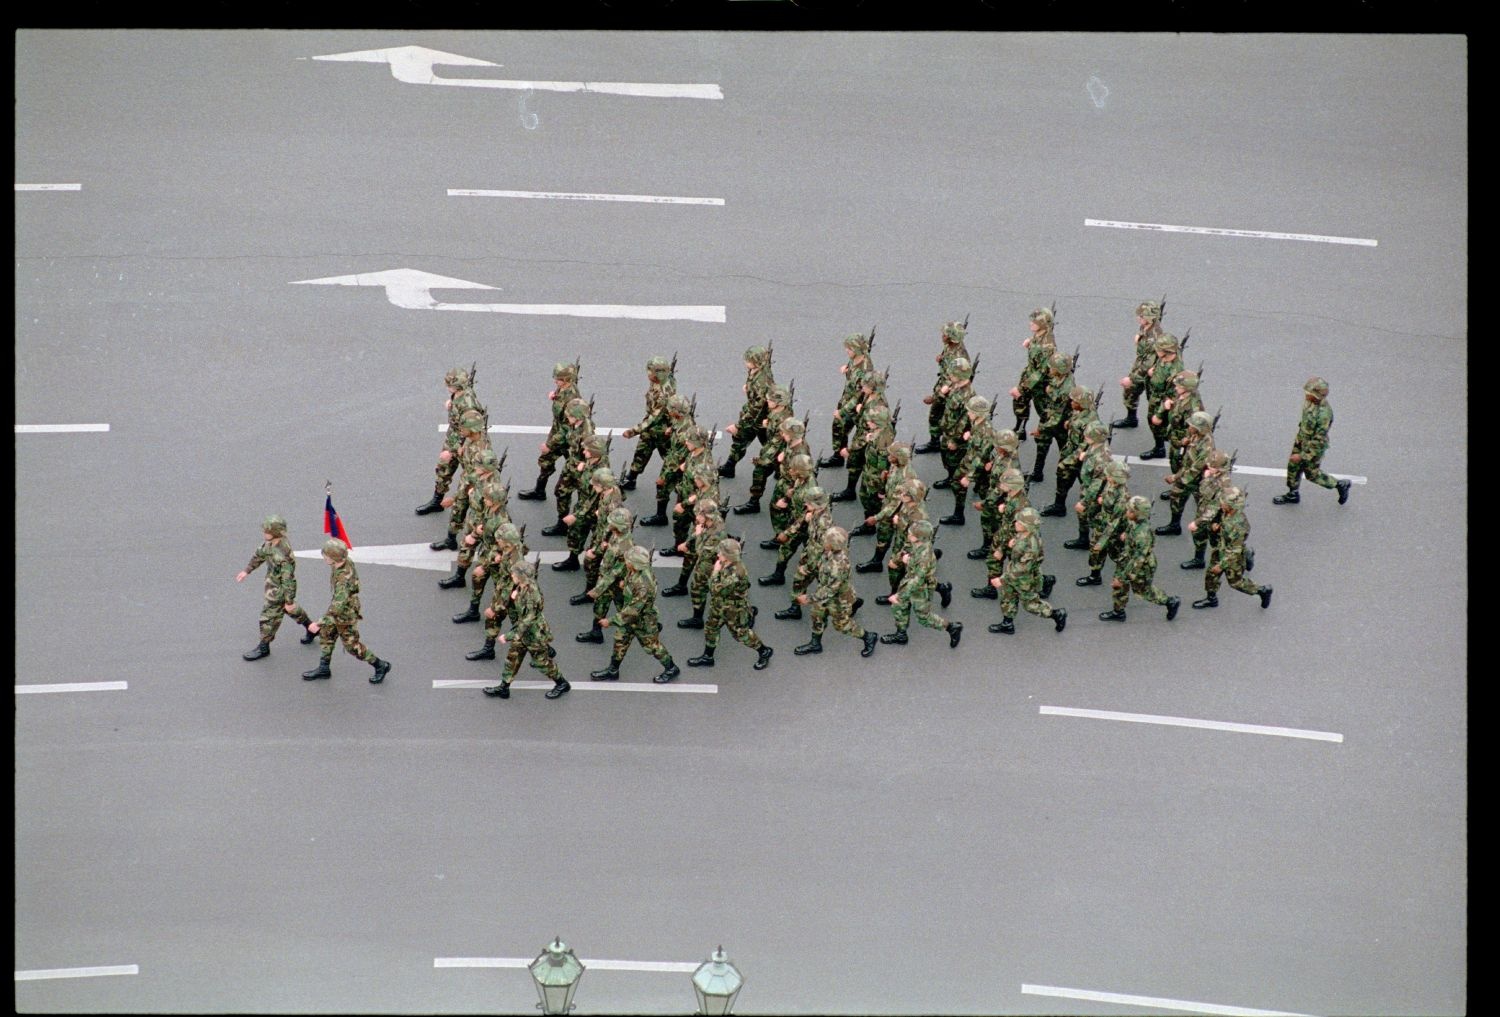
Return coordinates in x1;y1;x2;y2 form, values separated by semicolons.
15;32;1469;1014
